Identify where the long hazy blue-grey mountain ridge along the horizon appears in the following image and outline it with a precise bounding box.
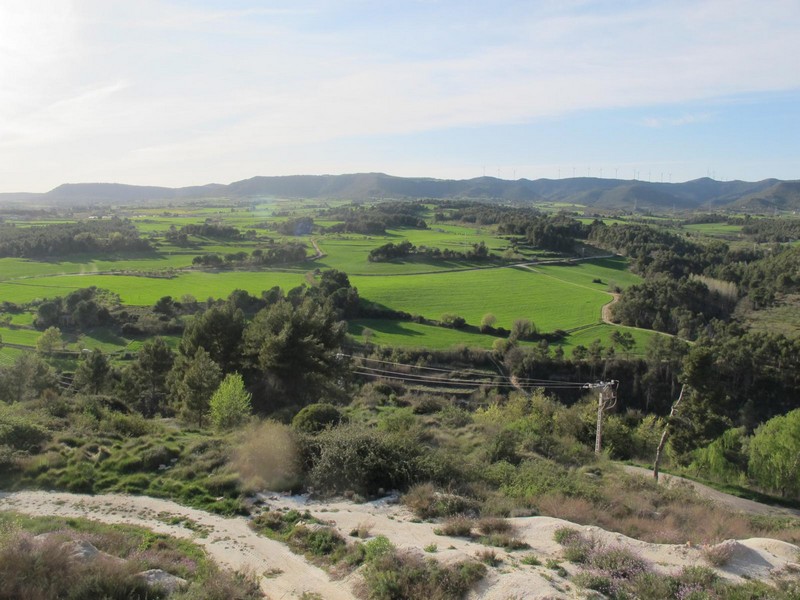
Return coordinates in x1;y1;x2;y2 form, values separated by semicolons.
0;173;800;211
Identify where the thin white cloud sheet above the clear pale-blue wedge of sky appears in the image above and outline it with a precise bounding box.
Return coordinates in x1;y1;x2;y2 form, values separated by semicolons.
0;0;800;187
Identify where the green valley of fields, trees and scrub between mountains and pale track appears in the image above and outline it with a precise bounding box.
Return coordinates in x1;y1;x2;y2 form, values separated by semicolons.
0;196;800;598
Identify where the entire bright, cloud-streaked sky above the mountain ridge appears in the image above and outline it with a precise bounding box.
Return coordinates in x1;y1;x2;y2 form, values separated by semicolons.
0;0;800;192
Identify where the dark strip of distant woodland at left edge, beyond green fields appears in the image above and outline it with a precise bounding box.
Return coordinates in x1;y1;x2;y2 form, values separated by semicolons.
0;218;152;258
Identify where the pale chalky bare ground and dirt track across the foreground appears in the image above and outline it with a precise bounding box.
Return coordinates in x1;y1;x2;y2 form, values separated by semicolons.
0;480;800;600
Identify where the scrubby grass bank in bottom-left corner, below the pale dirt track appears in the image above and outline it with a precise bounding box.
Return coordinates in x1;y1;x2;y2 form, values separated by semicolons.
0;512;262;600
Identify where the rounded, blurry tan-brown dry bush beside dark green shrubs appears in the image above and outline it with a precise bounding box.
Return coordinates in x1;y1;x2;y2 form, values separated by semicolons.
231;421;301;491
